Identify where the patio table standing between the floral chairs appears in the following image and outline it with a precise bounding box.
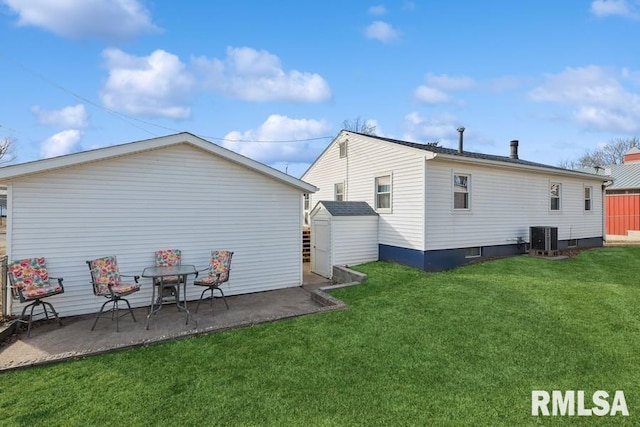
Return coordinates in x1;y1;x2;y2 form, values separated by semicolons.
142;265;197;330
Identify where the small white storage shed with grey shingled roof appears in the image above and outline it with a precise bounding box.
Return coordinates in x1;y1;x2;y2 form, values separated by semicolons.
310;201;378;279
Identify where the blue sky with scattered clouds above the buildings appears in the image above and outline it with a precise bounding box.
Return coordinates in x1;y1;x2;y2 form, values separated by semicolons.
0;0;640;176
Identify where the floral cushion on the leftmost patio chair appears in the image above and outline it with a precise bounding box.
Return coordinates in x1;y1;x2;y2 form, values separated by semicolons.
8;257;64;302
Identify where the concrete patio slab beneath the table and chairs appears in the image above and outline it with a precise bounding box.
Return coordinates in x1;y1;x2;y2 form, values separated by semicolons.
0;264;345;372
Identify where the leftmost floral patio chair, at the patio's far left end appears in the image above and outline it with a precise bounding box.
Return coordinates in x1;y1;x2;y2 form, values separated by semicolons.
7;257;64;337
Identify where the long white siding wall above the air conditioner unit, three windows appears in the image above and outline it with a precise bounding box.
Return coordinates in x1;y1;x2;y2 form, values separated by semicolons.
426;161;603;250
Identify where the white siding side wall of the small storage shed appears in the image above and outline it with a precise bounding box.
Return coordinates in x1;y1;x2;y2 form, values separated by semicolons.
331;216;378;265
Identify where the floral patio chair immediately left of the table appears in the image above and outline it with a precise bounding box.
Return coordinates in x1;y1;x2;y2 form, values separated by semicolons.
87;256;140;332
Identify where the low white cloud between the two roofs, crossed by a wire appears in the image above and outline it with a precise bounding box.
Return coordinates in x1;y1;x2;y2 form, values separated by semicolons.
222;114;330;164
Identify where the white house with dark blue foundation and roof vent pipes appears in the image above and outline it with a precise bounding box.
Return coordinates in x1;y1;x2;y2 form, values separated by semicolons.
302;130;609;271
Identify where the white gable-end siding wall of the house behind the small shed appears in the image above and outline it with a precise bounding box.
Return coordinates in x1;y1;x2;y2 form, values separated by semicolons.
302;134;425;250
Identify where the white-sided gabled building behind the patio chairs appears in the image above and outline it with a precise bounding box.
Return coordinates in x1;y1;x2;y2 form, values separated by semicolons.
0;133;316;316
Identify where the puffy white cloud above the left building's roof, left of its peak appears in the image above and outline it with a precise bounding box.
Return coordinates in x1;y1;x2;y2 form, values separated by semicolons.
100;49;195;119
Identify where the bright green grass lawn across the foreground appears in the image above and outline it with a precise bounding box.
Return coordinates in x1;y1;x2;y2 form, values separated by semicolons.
0;247;640;426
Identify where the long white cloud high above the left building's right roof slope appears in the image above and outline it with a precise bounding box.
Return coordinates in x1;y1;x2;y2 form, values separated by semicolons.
193;47;332;102
